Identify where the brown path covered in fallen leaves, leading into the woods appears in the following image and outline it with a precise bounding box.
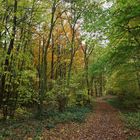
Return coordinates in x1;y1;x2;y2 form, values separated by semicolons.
43;98;126;140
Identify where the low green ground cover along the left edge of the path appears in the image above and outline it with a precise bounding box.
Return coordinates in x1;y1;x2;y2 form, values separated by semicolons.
0;107;91;140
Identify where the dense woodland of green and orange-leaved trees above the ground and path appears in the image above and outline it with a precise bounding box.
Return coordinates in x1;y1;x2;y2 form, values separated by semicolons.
0;0;140;139
